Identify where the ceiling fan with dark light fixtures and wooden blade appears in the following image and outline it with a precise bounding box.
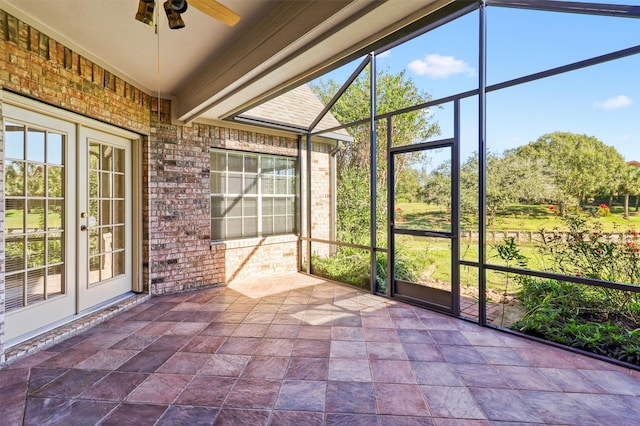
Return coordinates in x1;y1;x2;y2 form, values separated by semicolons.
136;0;240;30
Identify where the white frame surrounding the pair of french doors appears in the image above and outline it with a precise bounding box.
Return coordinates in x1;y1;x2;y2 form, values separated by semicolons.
0;89;144;348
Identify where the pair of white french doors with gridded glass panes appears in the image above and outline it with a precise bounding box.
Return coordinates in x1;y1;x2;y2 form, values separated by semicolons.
3;103;133;345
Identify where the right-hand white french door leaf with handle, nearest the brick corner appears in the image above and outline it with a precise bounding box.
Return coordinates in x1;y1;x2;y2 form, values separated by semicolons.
76;128;132;311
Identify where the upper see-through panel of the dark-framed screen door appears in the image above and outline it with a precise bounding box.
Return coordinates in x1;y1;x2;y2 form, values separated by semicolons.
394;147;451;232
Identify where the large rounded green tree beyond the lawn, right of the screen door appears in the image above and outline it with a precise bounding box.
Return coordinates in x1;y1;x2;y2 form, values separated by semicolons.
515;132;624;215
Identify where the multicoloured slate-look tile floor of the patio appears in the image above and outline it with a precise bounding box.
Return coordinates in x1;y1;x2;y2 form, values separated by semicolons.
0;274;640;426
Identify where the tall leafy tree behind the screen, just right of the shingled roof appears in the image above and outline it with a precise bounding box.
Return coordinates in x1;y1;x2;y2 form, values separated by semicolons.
311;68;440;243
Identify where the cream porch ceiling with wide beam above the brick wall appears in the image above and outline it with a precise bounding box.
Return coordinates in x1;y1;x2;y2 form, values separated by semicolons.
0;0;456;122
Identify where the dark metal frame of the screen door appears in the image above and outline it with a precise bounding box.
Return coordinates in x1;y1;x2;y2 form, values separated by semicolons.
387;99;460;317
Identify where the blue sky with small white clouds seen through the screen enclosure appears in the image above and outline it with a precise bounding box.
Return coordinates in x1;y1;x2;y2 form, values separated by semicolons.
316;0;640;160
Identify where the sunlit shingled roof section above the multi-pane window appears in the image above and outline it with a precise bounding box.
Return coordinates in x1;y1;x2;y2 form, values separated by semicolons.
241;85;350;140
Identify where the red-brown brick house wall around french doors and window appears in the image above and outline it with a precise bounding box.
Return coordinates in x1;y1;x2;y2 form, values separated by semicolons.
0;10;327;356
